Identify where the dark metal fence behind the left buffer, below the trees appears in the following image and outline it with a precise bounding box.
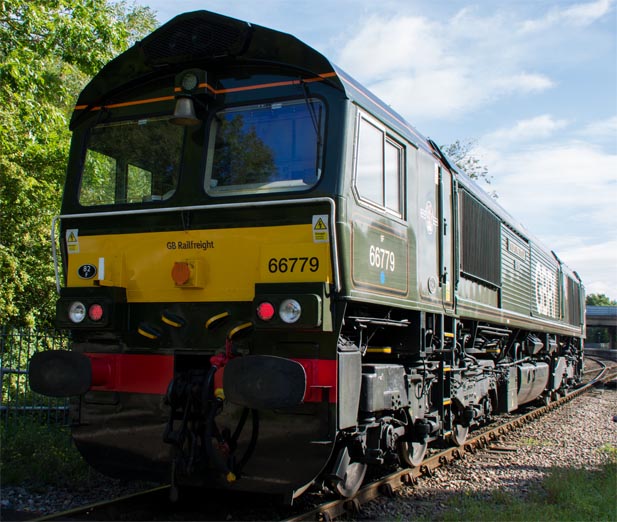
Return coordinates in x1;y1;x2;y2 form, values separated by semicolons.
0;326;69;425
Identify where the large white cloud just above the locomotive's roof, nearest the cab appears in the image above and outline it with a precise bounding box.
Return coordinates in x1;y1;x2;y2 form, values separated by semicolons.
336;13;555;121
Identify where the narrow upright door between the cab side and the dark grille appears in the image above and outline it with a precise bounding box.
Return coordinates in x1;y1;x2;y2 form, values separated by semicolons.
436;166;455;310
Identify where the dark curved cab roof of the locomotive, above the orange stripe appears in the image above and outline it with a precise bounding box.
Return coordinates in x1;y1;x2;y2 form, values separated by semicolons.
71;11;432;152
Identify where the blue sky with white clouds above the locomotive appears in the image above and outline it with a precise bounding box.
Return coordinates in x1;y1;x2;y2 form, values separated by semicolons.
136;0;617;299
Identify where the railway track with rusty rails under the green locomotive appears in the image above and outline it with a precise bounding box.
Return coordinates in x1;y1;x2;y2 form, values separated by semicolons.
37;358;617;521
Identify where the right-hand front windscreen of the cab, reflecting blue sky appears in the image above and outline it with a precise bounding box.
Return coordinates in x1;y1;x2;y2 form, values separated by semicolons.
205;99;324;196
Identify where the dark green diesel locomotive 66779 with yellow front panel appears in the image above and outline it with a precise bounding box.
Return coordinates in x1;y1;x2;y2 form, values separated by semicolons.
30;11;584;501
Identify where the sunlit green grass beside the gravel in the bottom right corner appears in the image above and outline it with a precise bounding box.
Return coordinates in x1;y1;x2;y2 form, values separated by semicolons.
414;445;617;522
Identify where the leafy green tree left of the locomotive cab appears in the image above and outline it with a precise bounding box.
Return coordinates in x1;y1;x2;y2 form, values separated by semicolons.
0;0;156;326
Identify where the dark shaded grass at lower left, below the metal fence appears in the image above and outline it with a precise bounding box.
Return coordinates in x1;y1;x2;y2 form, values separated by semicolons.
0;418;90;488
